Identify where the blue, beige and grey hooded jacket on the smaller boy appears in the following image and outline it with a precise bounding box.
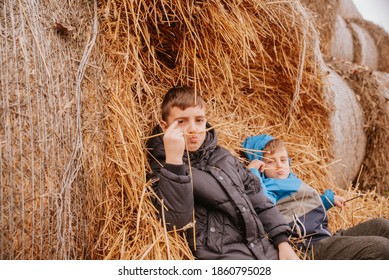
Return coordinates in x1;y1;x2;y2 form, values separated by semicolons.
243;134;334;249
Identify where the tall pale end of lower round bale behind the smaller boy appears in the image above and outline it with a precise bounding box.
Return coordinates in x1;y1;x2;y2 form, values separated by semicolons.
327;65;366;189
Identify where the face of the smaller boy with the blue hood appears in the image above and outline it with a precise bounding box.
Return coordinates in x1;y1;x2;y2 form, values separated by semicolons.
263;147;290;179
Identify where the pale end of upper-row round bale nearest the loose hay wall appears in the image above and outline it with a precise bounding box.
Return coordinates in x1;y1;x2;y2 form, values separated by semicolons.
325;15;355;62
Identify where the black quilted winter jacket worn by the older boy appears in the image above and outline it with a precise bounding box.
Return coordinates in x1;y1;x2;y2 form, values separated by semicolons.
147;126;290;259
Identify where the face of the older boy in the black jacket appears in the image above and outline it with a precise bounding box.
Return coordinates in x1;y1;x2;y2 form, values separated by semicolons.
161;106;207;152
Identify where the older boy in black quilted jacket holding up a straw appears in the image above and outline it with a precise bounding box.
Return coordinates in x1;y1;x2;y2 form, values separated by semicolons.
148;87;298;259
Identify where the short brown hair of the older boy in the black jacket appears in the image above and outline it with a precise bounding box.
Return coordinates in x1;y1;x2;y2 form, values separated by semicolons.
162;86;205;121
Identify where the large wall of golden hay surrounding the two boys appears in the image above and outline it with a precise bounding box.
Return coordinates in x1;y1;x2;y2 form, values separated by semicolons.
0;0;388;259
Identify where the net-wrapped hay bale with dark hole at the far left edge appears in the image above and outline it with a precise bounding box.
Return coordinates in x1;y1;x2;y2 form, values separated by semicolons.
0;1;101;259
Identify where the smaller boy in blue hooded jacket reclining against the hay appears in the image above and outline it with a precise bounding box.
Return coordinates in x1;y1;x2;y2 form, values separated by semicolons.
243;134;389;259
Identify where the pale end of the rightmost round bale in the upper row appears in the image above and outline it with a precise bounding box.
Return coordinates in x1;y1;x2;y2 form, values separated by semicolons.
350;22;379;70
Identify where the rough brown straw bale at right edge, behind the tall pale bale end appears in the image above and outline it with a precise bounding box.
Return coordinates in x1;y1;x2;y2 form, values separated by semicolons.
330;60;389;196
